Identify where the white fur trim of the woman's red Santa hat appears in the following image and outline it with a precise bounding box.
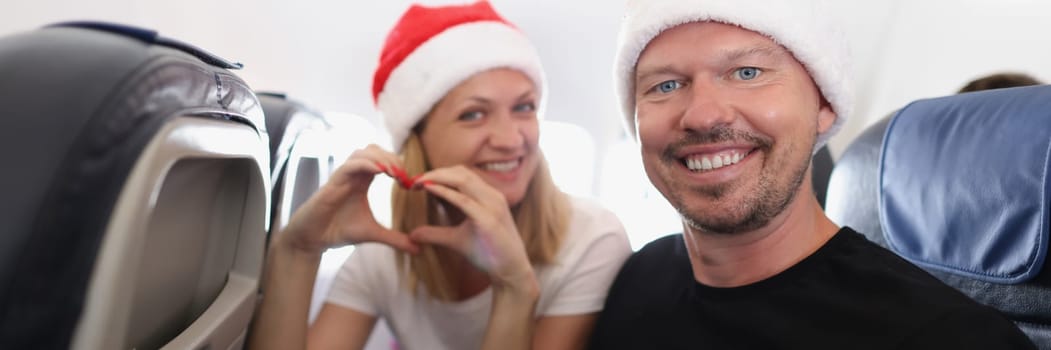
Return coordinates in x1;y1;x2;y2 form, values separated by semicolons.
377;21;545;152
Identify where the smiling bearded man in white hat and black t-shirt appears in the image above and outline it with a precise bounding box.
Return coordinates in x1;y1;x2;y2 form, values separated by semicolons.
592;0;1034;349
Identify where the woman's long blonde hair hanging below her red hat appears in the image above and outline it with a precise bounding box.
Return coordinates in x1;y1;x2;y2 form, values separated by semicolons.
391;131;570;301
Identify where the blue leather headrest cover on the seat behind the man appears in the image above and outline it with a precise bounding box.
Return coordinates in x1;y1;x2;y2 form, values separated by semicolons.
879;85;1051;284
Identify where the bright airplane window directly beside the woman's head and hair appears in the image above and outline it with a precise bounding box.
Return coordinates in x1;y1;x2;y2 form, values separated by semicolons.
540;121;595;197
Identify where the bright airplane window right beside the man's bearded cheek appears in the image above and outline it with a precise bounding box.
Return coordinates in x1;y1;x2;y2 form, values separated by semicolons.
599;134;682;250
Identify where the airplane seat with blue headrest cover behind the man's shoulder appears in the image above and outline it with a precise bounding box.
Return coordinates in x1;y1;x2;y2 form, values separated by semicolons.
827;85;1051;349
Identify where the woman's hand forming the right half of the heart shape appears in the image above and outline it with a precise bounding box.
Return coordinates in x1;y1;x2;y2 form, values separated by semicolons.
401;165;537;291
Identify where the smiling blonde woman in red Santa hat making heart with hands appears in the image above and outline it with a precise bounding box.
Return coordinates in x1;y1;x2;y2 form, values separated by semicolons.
250;2;631;349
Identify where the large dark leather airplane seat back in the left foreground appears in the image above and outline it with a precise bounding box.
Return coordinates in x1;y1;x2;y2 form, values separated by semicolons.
0;22;269;349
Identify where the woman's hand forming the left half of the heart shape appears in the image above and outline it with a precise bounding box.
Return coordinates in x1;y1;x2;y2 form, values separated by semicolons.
275;145;419;254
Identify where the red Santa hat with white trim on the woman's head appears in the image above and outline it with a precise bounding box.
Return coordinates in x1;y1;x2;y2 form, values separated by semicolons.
372;1;544;152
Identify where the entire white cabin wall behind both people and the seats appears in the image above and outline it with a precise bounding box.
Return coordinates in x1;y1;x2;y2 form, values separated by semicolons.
0;0;1051;178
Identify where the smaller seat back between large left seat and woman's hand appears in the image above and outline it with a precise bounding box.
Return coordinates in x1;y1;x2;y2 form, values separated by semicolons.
256;92;333;234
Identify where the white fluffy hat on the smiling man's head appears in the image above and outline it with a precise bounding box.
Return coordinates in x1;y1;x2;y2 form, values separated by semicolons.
615;0;853;150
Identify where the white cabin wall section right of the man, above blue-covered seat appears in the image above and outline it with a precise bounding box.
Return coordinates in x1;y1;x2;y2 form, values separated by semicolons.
830;0;1051;156
